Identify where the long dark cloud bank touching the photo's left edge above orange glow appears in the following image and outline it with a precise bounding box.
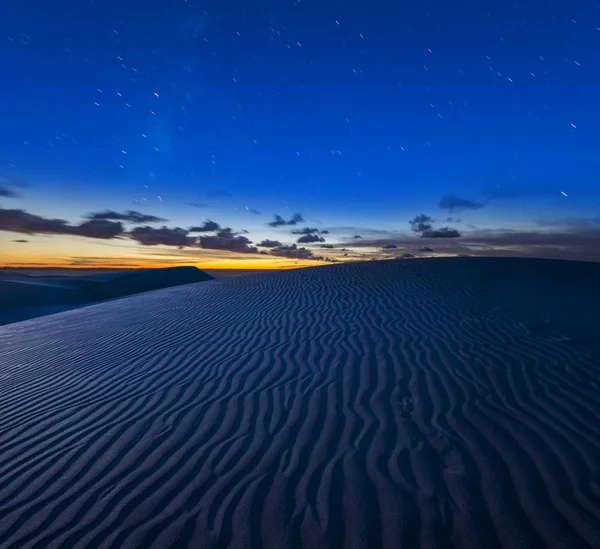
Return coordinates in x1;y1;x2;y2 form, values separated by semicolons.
0;209;124;239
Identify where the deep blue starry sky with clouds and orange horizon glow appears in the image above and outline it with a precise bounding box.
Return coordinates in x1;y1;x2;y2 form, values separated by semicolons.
0;0;600;268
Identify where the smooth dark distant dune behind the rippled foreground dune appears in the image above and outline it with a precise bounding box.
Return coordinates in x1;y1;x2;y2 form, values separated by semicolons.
0;267;213;325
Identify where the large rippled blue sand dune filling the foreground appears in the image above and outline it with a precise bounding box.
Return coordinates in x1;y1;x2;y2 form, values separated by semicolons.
0;258;600;549
